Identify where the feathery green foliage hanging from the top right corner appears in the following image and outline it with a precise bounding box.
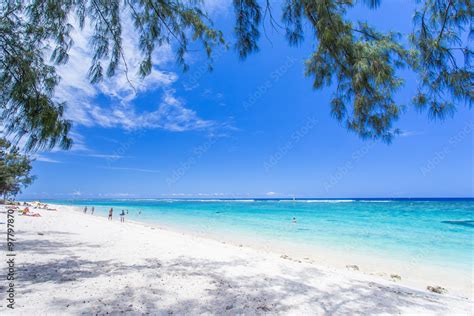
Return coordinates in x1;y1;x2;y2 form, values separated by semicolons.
283;0;473;142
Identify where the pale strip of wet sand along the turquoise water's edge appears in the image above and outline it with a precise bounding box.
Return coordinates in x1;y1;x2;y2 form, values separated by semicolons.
61;204;474;300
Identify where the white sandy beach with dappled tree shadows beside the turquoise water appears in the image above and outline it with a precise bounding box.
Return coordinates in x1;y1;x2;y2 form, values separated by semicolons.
0;206;474;315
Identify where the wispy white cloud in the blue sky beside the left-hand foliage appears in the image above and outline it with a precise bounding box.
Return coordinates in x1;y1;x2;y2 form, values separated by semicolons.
55;11;215;133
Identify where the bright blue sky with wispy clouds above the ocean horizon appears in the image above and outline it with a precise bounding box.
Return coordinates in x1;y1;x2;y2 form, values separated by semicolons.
20;0;474;199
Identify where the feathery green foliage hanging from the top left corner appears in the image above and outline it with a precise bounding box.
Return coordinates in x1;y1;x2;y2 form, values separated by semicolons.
0;0;225;150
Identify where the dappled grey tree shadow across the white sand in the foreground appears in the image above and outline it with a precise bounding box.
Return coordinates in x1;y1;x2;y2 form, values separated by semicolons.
1;228;462;315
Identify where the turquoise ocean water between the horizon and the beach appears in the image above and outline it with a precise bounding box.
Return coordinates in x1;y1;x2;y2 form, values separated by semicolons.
44;199;474;275
